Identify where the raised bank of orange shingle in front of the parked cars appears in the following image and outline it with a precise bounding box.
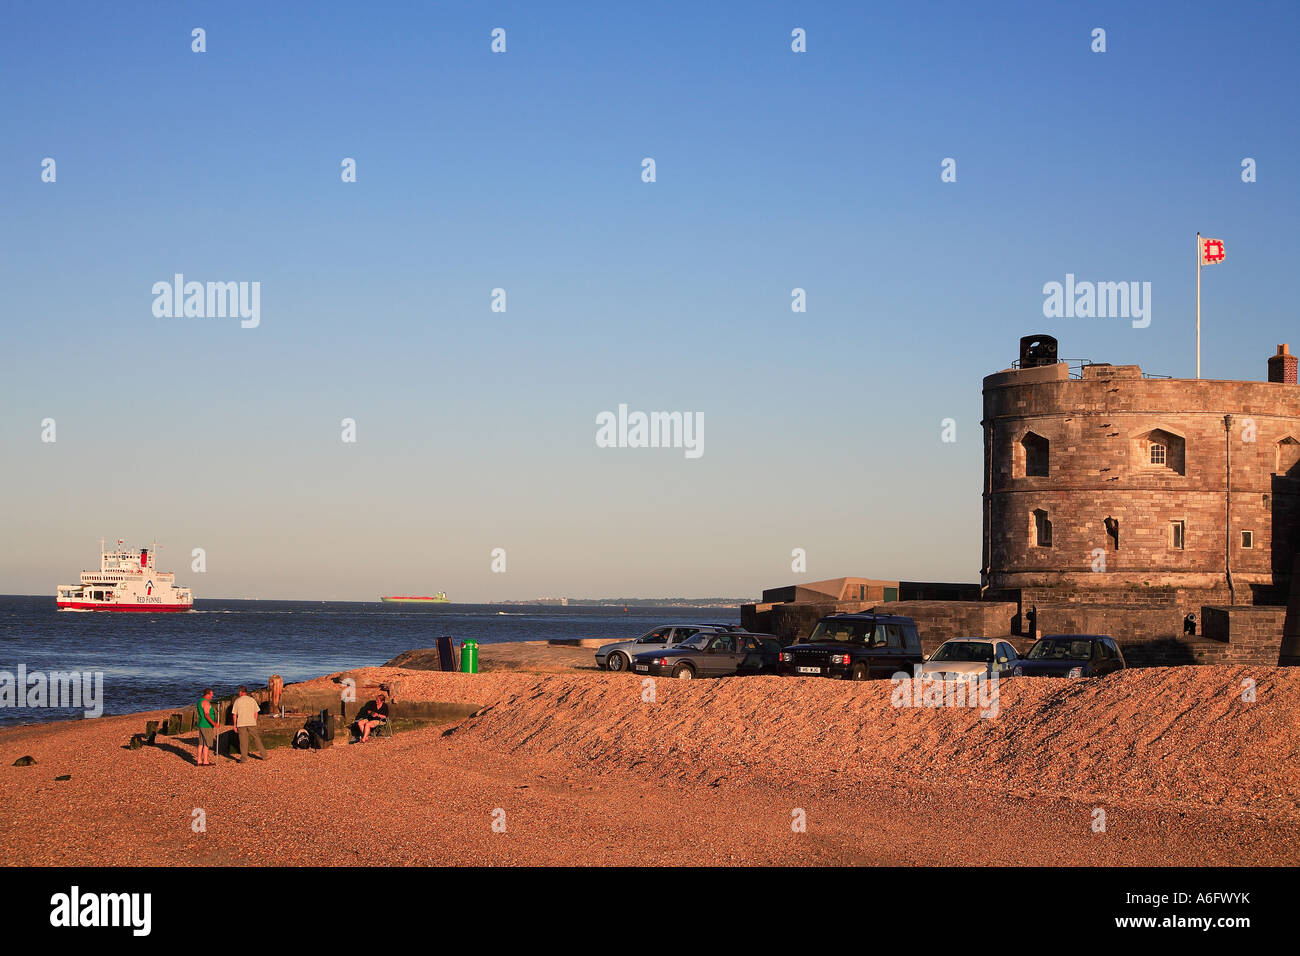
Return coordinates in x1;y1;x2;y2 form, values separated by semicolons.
455;666;1300;818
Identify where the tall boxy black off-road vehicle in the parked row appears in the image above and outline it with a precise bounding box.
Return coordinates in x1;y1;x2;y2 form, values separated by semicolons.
779;613;923;680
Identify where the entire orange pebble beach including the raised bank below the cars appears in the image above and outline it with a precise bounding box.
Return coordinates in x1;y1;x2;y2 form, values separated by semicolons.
0;645;1300;866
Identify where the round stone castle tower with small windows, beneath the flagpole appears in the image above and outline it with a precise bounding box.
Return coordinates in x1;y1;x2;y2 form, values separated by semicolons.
980;336;1300;613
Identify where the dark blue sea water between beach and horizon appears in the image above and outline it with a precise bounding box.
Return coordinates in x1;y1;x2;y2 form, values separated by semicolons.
0;596;740;726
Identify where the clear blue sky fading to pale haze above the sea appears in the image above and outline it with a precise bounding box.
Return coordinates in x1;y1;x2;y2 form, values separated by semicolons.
0;3;1300;601
